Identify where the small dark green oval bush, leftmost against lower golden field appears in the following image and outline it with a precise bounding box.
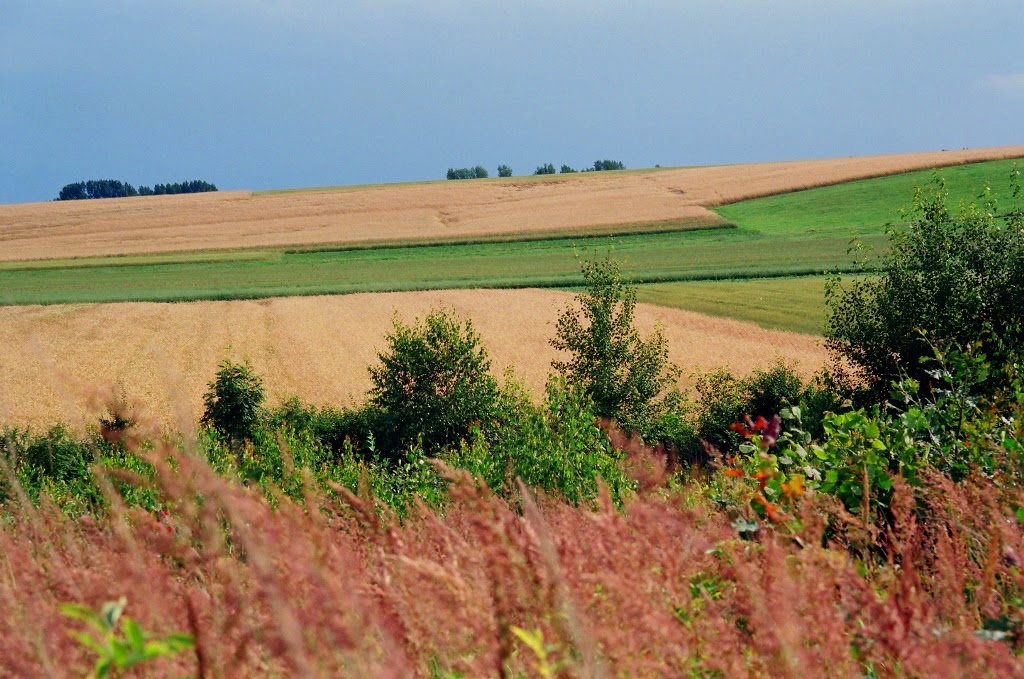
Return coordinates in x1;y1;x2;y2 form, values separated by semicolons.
202;358;264;447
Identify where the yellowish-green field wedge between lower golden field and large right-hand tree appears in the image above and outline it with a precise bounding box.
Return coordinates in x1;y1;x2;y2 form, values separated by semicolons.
637;275;826;335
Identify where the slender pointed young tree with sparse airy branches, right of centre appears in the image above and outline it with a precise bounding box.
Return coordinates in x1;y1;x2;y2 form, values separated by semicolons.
551;258;680;430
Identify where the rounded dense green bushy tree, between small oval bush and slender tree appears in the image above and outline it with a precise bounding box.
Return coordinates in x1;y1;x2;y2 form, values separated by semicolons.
370;309;499;453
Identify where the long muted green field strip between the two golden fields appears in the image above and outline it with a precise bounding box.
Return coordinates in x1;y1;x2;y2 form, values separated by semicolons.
0;228;884;304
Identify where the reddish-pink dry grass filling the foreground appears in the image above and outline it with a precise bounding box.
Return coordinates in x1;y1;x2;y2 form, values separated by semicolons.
0;451;1024;678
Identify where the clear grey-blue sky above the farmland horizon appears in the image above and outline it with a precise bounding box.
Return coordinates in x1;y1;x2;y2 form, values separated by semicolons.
0;0;1024;203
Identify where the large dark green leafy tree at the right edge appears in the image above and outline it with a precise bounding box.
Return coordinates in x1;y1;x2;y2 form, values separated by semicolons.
825;168;1024;397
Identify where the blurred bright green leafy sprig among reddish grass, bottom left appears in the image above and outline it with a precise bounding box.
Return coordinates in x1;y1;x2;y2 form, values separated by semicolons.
60;597;195;679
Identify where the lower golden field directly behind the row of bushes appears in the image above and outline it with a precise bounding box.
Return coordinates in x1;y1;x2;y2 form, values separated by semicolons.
0;290;825;426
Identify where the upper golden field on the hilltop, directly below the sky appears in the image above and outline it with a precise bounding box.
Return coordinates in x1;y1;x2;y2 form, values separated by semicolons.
0;146;1024;260
